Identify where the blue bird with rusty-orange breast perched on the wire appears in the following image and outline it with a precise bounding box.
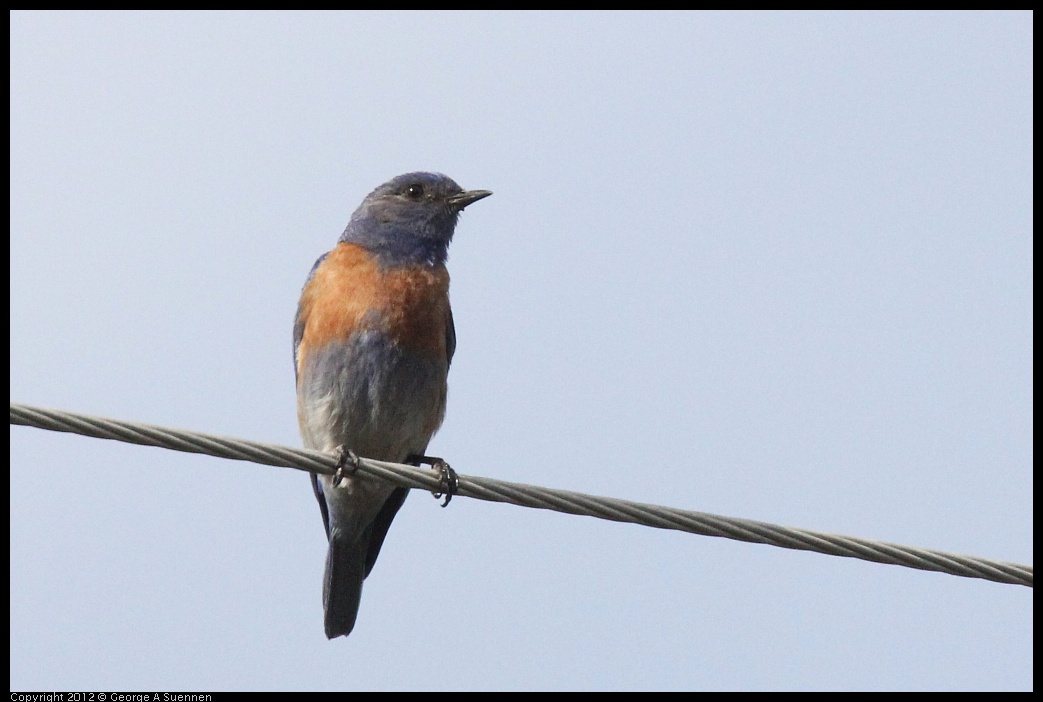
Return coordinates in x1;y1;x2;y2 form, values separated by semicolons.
293;172;492;639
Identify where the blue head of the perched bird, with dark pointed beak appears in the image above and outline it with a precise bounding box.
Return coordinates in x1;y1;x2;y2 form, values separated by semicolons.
340;172;492;267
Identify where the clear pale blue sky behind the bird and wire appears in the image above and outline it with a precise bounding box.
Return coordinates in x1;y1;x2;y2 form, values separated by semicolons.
10;11;1033;692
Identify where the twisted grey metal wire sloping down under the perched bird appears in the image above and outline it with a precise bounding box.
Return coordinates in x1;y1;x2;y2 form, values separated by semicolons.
10;403;1033;587
